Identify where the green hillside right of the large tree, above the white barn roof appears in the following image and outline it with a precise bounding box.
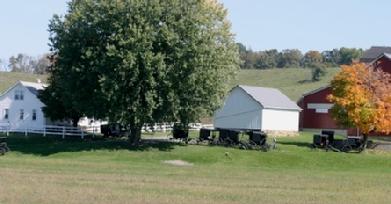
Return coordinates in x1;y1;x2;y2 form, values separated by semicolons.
232;68;339;101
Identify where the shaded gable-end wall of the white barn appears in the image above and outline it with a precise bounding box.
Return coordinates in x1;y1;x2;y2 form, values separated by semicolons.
214;88;262;130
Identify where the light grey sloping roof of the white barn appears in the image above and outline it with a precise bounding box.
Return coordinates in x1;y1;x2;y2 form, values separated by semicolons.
237;85;301;110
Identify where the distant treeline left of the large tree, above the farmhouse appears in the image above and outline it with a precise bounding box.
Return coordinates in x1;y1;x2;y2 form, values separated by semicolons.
0;54;50;74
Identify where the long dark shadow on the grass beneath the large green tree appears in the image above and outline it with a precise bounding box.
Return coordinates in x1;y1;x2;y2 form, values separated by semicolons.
7;136;181;156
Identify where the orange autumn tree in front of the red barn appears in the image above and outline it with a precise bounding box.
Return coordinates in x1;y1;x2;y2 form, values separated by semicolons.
328;63;391;146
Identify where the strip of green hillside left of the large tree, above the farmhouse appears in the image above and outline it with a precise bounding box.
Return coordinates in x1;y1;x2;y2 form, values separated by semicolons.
0;72;47;93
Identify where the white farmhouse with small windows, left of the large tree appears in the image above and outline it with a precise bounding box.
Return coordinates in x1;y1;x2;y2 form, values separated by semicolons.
0;81;46;130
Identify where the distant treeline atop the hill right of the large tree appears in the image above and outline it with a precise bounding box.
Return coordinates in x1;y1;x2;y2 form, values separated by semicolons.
238;43;363;69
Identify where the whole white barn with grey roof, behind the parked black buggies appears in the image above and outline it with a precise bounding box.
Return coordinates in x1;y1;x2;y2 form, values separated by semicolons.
214;85;301;132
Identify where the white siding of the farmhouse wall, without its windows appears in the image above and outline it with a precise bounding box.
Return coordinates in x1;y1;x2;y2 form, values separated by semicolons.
0;83;45;129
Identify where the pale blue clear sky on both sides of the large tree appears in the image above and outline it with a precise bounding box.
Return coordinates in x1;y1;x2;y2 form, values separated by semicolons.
0;0;391;61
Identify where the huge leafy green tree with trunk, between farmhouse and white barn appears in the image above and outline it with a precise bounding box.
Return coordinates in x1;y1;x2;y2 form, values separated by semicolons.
42;0;239;141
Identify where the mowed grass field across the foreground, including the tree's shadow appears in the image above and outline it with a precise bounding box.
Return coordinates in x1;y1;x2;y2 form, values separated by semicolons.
0;133;391;204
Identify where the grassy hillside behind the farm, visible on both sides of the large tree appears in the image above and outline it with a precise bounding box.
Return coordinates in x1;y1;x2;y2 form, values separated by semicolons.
0;68;339;101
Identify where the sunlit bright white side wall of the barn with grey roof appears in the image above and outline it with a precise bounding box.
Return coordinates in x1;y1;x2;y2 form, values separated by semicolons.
262;109;299;131
